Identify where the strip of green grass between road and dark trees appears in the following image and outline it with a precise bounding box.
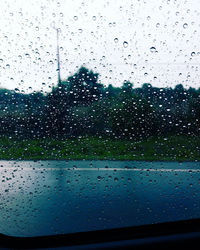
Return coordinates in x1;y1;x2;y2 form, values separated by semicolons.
0;136;200;161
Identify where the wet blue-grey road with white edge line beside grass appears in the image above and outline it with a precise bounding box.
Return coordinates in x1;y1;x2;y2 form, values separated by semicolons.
0;161;200;236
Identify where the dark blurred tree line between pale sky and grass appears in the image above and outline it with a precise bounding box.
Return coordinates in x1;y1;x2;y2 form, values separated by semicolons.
0;67;200;139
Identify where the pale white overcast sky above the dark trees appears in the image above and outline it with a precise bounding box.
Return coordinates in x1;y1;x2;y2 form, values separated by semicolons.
0;0;200;92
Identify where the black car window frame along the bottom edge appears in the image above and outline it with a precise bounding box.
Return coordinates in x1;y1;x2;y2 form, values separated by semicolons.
0;219;200;249
